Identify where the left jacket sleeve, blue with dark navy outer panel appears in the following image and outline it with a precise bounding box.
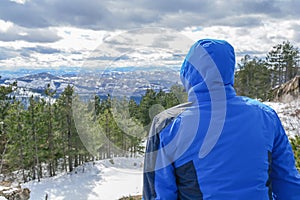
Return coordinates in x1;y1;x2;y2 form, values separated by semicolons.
143;125;177;200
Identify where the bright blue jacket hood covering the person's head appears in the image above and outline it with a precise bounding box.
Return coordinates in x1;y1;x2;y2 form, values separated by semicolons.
180;39;235;100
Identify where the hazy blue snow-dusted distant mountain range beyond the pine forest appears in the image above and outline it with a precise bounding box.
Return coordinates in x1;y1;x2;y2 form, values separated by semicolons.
0;67;180;101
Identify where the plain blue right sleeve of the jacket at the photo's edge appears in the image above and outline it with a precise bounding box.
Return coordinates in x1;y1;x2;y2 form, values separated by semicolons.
270;115;300;200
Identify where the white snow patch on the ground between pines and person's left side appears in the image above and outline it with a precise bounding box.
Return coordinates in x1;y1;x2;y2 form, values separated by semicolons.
22;158;143;200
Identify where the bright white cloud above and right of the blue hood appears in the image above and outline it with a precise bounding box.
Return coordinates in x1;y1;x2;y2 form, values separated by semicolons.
182;18;300;62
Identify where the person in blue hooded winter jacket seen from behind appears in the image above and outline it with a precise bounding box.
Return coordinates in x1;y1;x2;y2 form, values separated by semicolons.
143;39;300;200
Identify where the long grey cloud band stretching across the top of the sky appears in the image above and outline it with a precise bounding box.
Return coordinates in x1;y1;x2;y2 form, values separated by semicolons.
0;0;300;30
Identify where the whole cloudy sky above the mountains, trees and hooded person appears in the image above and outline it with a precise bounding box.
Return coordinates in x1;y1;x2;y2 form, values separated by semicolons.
0;0;300;70
